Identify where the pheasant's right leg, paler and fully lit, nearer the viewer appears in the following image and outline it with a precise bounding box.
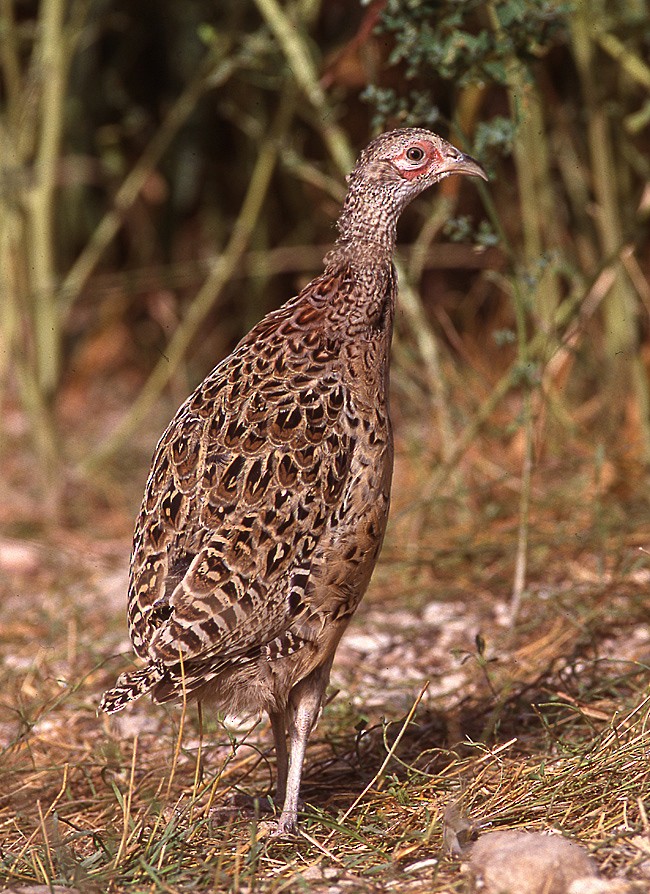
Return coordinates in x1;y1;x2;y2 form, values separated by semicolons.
275;655;334;835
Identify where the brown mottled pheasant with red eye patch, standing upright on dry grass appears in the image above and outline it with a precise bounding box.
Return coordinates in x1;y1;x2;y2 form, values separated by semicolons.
100;128;487;834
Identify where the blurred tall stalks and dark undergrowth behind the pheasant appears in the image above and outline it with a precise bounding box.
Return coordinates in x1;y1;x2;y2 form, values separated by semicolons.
0;0;650;560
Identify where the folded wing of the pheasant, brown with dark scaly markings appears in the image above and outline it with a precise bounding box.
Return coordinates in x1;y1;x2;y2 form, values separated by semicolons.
129;288;356;664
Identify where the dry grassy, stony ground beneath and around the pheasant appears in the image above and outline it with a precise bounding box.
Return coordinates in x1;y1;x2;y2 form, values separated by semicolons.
0;414;650;892
